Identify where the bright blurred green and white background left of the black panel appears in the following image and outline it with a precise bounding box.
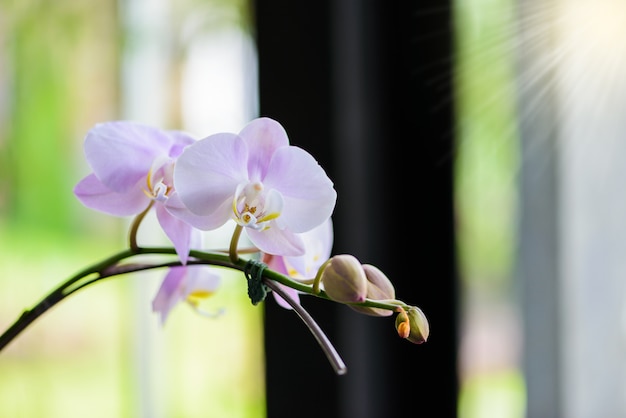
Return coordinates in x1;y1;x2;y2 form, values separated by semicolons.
0;0;265;418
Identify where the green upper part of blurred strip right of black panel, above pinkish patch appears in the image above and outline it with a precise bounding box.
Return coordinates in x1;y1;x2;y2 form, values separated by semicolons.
456;0;518;287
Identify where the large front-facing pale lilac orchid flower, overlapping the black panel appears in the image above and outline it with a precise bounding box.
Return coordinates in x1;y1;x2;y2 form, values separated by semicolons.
174;118;337;256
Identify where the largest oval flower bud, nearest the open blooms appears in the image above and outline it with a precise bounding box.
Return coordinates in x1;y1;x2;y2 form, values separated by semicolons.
321;254;367;303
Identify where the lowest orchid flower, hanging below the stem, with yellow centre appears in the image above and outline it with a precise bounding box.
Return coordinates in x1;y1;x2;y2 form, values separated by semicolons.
152;266;220;325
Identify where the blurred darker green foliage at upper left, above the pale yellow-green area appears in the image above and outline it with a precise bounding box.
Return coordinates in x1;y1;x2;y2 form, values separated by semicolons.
0;1;117;234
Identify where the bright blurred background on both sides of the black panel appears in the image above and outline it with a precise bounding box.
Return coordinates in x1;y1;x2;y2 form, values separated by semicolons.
0;0;626;418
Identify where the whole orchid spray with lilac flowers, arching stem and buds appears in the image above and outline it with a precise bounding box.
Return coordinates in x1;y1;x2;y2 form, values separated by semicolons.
0;117;428;372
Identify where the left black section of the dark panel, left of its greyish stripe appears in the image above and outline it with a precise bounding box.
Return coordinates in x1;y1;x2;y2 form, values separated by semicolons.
255;0;339;418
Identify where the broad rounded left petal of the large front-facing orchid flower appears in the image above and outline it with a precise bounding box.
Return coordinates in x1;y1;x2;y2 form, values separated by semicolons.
174;133;248;222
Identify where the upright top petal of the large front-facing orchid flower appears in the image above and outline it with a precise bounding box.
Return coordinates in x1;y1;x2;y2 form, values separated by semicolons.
239;118;289;181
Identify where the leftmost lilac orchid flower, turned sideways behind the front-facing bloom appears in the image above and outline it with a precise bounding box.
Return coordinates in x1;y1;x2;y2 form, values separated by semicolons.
74;121;212;263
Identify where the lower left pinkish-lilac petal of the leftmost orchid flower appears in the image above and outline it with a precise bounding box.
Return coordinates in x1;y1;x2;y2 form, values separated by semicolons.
74;173;150;216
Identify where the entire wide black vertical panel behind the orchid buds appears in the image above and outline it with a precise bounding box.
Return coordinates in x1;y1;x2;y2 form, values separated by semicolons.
255;0;458;418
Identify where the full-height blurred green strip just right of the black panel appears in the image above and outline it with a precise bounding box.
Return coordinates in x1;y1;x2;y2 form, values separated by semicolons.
454;0;525;418
